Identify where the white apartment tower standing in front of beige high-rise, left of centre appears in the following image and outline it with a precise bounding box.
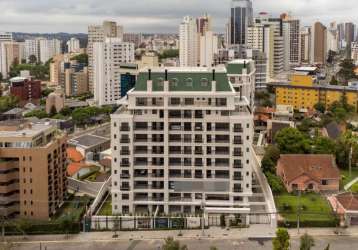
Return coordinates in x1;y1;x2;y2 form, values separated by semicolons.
92;38;135;106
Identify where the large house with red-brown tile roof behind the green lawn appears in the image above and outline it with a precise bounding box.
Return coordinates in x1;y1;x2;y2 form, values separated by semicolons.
276;154;340;193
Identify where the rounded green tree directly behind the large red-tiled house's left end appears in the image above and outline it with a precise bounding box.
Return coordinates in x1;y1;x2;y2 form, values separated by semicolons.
275;127;310;154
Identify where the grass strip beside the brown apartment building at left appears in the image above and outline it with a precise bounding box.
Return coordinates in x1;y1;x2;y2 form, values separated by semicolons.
52;195;91;221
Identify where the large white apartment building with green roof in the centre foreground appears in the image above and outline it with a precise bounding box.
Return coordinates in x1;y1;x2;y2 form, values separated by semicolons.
111;67;253;223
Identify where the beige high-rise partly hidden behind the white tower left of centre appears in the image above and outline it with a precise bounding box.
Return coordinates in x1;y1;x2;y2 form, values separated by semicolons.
87;21;123;93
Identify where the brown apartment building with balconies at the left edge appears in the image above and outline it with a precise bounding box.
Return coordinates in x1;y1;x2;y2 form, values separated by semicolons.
0;120;67;220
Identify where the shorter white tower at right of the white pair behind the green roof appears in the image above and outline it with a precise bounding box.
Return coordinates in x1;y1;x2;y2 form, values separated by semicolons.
200;31;218;67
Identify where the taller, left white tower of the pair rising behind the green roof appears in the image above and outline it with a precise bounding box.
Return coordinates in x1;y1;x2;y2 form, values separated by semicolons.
179;16;199;67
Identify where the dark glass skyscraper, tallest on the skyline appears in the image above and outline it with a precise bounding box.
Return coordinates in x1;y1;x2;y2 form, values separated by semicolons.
229;0;253;45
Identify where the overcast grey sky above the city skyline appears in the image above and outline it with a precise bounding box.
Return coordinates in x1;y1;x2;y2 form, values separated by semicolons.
0;0;358;33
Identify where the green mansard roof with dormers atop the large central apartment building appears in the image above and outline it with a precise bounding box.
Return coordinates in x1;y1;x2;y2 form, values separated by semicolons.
134;71;231;92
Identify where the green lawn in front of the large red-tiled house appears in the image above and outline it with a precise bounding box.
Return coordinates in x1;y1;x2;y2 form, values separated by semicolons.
275;193;335;226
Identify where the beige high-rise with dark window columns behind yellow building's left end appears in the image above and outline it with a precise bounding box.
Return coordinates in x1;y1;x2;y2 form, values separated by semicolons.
281;14;301;70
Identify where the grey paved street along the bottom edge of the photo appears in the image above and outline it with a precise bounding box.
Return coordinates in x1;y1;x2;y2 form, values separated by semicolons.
10;236;358;250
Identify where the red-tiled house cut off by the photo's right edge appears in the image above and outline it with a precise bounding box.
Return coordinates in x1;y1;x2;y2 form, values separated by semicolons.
328;193;358;226
